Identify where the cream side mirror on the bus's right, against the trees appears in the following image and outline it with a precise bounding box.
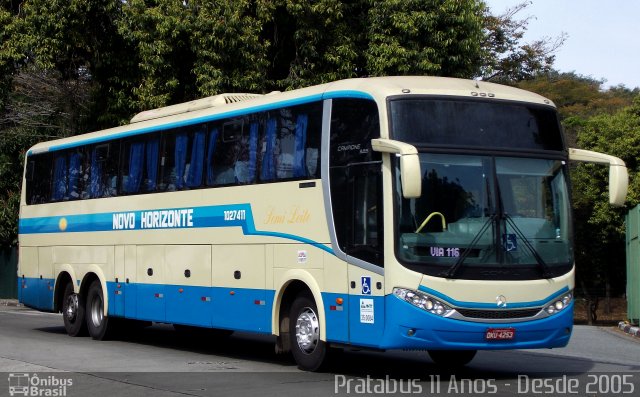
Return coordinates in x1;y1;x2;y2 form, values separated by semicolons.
569;149;629;207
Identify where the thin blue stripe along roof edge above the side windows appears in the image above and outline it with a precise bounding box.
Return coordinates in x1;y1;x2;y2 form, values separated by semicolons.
27;90;373;156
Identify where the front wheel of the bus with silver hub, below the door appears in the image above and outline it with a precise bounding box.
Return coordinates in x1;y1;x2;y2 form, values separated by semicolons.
289;292;328;371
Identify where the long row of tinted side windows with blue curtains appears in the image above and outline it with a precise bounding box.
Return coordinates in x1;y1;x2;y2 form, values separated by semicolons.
25;102;322;204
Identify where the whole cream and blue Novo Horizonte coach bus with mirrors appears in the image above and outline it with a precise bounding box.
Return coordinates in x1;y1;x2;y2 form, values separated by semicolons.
18;77;627;371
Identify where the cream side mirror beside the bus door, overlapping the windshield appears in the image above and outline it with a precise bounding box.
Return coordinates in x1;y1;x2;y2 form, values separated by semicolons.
371;138;422;199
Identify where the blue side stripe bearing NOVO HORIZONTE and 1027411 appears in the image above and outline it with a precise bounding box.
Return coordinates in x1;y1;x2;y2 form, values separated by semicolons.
19;204;333;255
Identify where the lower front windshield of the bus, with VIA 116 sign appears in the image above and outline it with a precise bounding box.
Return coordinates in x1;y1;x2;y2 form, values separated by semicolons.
395;153;573;277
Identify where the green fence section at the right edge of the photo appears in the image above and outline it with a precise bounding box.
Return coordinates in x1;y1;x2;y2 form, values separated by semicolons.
626;205;640;324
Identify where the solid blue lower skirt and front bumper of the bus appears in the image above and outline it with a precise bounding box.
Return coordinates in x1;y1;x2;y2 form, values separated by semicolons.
18;277;574;350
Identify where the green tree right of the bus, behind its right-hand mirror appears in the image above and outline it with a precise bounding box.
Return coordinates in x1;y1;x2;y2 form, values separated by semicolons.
571;96;640;312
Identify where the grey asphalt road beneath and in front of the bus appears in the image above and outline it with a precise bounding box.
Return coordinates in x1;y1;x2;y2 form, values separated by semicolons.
0;306;640;397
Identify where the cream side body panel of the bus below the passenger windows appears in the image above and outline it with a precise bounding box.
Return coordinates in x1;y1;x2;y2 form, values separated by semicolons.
20;181;332;324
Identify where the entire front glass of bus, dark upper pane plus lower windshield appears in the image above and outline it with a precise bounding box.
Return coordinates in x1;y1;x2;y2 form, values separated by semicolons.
392;100;573;279
